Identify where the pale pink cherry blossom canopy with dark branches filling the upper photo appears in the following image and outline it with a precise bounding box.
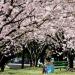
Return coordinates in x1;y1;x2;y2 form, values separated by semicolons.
0;0;75;71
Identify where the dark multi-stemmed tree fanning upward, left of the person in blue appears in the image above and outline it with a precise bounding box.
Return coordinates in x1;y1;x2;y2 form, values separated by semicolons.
20;39;46;67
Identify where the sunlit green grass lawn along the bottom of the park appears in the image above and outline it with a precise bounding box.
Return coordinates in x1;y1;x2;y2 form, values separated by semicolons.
0;68;75;75
